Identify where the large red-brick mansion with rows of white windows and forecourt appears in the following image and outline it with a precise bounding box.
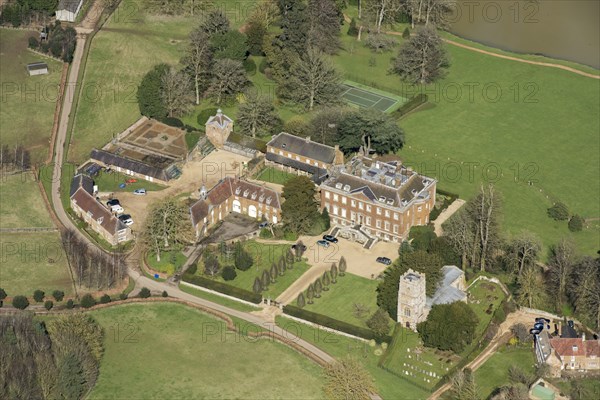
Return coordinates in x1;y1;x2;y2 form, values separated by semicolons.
321;156;436;247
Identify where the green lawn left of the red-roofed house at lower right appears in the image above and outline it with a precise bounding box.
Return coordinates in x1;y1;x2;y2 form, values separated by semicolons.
475;347;535;399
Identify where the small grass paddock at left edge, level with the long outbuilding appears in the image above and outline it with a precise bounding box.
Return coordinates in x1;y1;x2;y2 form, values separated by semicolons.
0;172;53;228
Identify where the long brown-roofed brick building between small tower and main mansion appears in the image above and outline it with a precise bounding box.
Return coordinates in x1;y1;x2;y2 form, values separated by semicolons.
265;132;344;185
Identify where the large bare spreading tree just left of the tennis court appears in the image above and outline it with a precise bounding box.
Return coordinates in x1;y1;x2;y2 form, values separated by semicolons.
282;47;342;111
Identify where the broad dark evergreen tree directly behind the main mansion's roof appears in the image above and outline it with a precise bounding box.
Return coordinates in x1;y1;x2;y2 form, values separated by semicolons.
338;109;404;156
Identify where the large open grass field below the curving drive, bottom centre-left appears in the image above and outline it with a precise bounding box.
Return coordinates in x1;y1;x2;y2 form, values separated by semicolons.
90;304;322;399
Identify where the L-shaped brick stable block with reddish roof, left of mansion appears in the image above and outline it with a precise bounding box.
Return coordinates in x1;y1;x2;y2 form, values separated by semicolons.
190;177;281;237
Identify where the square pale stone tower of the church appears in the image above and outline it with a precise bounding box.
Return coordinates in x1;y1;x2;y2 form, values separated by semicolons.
397;269;427;331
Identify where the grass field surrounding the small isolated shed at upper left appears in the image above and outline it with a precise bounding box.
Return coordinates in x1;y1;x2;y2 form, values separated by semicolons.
0;29;62;162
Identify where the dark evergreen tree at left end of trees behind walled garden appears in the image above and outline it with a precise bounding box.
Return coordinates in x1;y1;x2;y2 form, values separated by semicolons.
137;64;170;119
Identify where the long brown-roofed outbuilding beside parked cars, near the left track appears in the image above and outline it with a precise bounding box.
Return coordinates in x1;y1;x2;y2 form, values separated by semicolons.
70;174;132;246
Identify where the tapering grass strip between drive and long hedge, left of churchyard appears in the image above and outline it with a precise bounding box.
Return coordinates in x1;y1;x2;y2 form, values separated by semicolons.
275;317;431;400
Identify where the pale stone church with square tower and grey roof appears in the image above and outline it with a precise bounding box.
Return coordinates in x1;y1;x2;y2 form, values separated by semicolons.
397;265;467;331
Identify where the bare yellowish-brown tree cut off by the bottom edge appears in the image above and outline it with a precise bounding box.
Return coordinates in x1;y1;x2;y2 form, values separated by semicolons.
323;356;375;400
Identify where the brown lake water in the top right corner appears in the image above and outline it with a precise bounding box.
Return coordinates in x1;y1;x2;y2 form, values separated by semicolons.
448;0;600;69
